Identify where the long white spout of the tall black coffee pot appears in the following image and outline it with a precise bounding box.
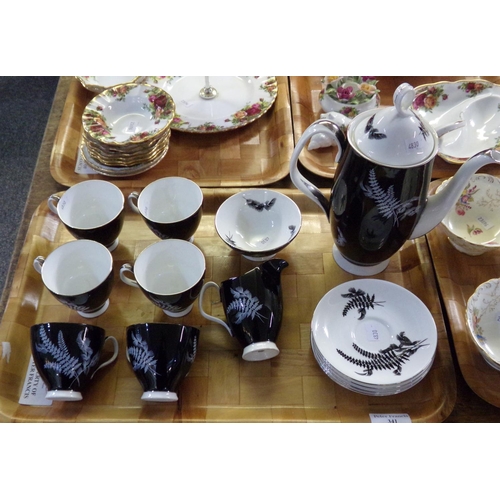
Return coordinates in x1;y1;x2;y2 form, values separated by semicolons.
410;149;500;239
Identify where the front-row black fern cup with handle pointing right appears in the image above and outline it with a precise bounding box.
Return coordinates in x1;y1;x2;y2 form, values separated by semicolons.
30;322;118;401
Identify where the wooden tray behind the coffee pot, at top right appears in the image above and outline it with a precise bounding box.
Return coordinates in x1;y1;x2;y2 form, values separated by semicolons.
290;76;499;179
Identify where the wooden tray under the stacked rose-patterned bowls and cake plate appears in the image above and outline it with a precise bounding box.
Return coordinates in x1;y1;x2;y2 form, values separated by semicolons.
50;76;293;188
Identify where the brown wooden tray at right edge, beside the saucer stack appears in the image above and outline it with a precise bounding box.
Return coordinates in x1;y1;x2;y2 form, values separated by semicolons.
427;181;500;407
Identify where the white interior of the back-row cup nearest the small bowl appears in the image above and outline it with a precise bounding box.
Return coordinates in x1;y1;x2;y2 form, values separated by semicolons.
137;177;203;223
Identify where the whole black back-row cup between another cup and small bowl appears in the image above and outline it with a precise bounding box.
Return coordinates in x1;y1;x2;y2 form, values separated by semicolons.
128;177;203;241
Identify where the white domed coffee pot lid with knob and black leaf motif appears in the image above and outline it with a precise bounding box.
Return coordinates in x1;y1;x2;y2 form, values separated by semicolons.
347;83;438;167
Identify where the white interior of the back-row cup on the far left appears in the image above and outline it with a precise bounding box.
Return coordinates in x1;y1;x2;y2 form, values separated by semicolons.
57;180;125;229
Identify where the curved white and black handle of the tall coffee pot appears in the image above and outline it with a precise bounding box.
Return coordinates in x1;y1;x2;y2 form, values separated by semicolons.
290;118;347;217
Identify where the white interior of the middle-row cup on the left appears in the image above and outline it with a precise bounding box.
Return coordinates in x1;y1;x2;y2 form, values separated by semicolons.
42;240;113;296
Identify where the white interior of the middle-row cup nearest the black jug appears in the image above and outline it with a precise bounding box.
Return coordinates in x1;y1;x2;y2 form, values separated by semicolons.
134;239;205;295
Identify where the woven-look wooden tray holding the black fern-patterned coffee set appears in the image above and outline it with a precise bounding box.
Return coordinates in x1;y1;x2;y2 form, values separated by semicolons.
0;189;457;422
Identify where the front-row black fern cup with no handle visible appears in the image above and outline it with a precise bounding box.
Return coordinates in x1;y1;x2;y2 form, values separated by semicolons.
127;323;200;402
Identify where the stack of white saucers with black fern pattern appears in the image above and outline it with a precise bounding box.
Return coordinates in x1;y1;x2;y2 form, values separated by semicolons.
311;279;437;396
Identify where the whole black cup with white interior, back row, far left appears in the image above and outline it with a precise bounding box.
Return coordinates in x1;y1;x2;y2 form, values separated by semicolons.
47;179;125;252
